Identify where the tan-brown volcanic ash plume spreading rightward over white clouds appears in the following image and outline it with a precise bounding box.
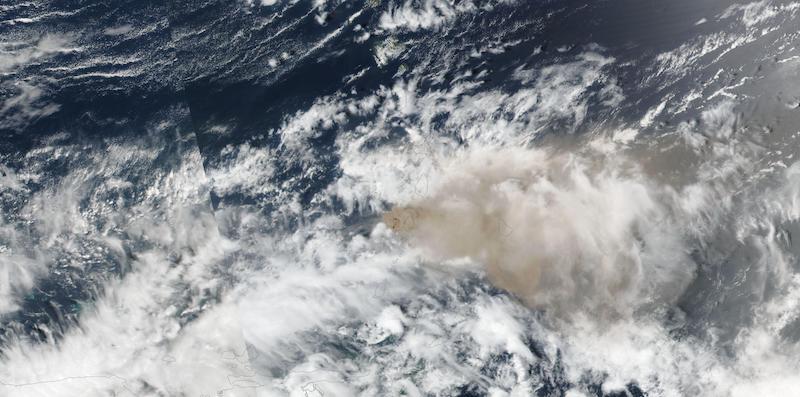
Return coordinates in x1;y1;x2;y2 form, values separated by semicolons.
383;149;693;316
